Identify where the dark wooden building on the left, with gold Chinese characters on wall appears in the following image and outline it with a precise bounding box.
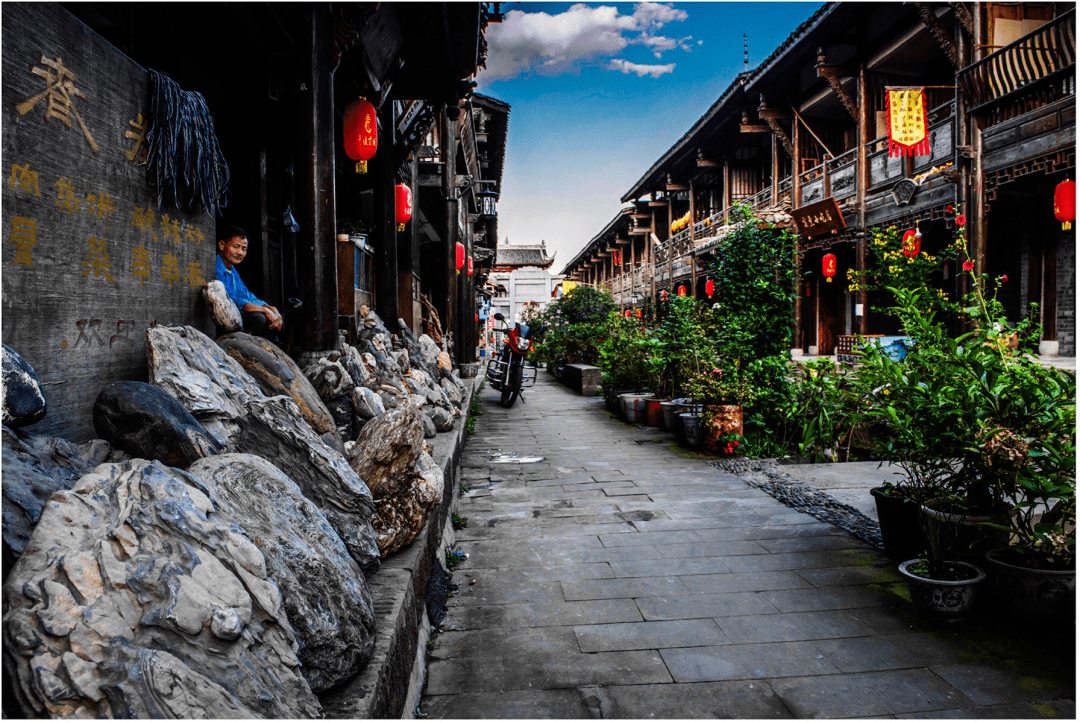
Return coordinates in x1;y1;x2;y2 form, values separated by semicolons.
0;2;509;440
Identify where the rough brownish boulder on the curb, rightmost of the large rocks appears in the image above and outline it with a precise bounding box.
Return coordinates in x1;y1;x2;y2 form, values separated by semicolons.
349;405;442;555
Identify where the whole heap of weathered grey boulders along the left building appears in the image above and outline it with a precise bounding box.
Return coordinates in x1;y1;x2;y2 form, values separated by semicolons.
2;309;464;718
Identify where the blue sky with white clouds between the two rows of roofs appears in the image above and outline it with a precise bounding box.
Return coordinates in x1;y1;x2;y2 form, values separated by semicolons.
476;2;821;271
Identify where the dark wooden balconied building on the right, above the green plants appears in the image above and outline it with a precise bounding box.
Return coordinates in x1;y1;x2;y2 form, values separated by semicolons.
564;2;1076;357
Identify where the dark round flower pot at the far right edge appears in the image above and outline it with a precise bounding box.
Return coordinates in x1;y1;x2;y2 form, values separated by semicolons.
986;548;1077;622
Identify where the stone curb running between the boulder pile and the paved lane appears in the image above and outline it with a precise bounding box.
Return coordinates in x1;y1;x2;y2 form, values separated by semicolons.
319;377;483;719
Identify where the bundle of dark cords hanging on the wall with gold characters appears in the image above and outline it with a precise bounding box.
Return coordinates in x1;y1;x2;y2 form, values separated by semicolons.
147;70;229;216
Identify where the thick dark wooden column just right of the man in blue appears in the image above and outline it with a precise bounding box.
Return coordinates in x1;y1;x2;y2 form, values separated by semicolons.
297;4;338;350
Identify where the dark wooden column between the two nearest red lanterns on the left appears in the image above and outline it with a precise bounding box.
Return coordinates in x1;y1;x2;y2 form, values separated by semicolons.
372;101;399;332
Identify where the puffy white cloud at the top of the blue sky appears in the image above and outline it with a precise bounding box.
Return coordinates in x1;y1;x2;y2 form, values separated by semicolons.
481;2;692;81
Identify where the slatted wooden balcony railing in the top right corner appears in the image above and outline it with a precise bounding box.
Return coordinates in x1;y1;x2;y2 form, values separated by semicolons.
957;9;1076;110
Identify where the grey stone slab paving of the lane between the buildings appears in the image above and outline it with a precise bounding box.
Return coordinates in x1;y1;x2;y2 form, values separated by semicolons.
420;373;1075;719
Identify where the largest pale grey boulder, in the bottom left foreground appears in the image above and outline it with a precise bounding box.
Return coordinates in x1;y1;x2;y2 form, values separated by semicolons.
3;459;321;719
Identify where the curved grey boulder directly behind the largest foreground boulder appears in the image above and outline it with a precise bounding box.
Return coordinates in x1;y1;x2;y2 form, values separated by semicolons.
188;454;375;692
